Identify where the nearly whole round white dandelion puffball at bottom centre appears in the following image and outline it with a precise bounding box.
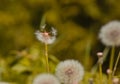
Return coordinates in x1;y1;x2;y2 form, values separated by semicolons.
56;60;84;84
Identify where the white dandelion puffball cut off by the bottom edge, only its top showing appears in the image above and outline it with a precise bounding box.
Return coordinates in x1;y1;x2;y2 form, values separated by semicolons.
33;74;60;84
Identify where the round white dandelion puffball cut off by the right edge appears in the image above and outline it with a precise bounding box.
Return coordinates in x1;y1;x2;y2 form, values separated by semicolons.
99;21;120;46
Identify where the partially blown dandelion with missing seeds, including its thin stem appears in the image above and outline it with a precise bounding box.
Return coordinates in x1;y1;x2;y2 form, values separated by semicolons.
35;24;57;72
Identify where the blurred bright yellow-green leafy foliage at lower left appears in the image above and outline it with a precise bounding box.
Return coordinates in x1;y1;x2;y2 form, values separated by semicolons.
0;45;59;84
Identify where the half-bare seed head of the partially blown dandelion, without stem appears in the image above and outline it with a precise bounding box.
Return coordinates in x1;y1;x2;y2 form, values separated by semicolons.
35;28;56;44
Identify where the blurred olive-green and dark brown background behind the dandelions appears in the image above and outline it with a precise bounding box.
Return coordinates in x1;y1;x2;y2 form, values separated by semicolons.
0;0;120;84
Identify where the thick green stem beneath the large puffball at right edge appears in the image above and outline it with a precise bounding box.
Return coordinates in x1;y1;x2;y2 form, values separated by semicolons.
108;46;115;84
